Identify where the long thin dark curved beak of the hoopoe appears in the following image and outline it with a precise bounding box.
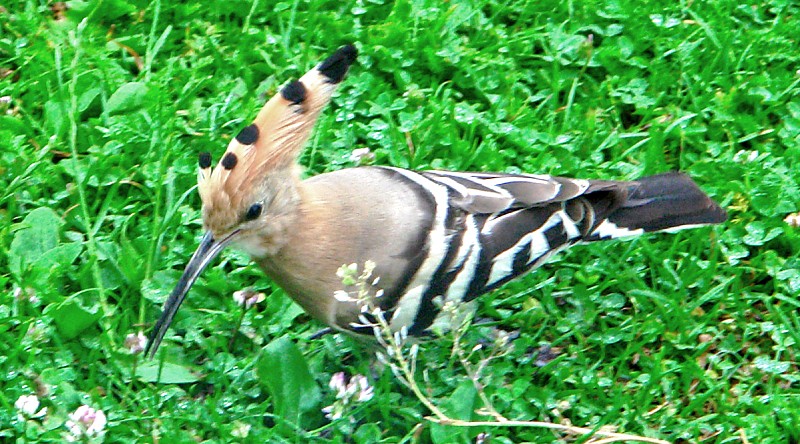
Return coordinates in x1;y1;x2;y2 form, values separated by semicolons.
144;231;238;359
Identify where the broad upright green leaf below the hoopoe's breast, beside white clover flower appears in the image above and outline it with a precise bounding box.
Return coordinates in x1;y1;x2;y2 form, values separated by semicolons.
256;336;320;425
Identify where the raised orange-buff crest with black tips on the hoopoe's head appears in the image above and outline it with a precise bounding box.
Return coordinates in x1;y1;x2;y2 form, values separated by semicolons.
197;45;357;236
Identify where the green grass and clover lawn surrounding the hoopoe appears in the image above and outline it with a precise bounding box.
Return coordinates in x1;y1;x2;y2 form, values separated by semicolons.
0;0;800;443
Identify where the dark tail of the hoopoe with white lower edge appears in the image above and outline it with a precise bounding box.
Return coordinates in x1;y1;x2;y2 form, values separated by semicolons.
587;172;728;241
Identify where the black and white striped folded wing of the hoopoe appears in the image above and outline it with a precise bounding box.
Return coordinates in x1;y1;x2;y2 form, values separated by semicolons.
374;168;626;334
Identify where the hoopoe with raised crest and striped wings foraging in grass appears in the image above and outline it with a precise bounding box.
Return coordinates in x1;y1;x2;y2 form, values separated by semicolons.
142;45;727;357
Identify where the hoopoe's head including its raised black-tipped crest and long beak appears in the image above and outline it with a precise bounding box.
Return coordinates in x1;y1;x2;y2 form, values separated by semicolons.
145;45;357;357
